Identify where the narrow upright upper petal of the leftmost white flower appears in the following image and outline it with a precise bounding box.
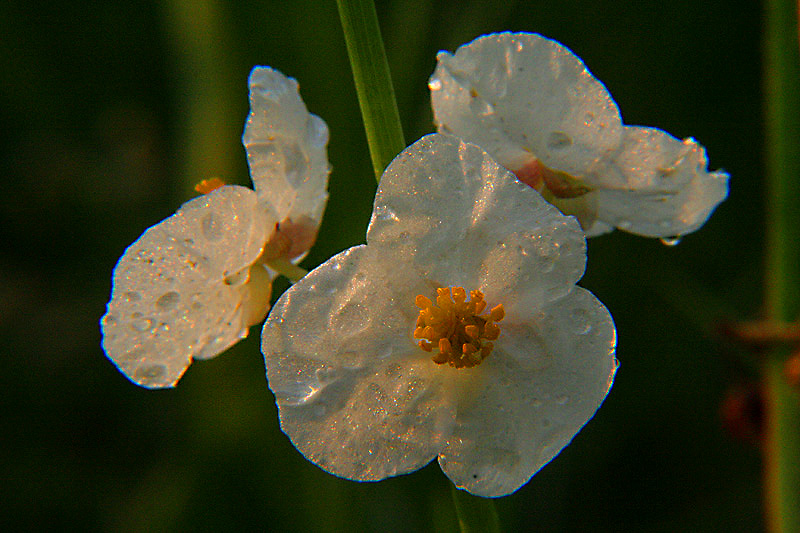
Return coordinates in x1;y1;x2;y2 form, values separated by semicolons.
242;67;330;226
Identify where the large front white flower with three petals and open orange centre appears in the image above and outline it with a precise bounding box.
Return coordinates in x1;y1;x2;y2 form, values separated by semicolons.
262;134;616;497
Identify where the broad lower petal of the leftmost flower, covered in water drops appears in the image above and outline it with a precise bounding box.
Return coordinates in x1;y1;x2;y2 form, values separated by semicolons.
101;186;274;388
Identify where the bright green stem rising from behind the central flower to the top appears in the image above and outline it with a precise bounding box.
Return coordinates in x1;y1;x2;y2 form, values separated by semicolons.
336;0;406;181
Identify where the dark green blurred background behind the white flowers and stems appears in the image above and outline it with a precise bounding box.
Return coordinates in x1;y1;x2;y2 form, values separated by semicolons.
0;0;764;532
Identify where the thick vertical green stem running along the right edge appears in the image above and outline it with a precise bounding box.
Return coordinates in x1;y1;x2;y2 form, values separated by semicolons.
764;0;800;532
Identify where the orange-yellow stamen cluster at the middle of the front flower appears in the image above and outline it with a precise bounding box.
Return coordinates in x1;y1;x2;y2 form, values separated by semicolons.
414;287;506;368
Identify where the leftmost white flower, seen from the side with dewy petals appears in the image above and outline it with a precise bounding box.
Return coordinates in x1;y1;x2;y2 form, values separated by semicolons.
101;67;328;388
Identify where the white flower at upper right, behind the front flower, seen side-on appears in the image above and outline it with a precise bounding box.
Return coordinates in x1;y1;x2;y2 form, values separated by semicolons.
428;33;728;238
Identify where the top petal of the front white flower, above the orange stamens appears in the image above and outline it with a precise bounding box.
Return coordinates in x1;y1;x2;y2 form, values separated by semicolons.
367;134;586;303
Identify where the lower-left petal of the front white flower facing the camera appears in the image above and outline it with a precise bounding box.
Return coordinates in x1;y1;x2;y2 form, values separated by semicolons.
262;246;452;481
